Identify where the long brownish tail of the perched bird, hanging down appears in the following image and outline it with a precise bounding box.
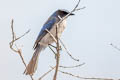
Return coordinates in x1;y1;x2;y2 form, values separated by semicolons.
24;44;45;75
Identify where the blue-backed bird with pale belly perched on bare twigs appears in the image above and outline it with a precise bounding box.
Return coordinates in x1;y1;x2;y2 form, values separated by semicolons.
24;9;74;75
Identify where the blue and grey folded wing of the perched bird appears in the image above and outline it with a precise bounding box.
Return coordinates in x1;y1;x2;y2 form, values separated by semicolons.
33;18;57;49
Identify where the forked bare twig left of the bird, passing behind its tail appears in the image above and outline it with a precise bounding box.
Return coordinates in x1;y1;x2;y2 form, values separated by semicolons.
9;19;34;80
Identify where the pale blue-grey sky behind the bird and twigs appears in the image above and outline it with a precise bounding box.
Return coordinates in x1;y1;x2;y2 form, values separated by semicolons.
0;0;120;80
